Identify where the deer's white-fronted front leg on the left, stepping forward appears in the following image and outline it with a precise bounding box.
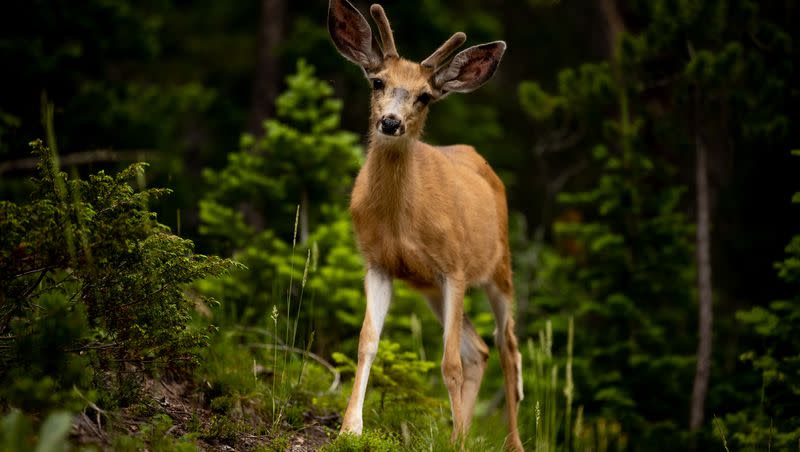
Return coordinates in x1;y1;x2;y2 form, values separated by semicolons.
341;268;392;435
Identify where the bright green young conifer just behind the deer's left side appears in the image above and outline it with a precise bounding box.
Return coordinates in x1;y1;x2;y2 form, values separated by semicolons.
200;62;361;352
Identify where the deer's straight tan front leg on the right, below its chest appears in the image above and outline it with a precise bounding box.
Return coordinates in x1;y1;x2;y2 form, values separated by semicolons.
442;277;466;442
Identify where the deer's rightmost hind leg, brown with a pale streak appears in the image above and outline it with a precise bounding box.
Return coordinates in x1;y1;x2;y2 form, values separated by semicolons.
486;266;523;451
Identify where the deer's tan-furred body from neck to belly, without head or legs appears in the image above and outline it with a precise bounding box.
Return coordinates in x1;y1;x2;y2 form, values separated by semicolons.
350;139;510;290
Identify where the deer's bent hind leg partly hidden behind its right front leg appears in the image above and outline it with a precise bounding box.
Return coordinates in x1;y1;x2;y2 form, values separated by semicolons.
423;289;489;435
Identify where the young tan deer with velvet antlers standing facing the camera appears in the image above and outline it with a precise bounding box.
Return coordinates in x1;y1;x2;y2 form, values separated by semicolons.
328;0;523;450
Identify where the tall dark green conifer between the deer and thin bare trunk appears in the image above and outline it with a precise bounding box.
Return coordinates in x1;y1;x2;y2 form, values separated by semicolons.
524;73;693;441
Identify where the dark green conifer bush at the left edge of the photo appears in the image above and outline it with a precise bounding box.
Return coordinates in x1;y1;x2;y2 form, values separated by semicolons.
0;141;232;411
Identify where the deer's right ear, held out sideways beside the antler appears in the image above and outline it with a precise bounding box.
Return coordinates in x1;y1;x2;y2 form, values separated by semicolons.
433;41;506;93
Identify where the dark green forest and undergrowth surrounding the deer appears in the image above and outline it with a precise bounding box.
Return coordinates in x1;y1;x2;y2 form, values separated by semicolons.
0;0;800;450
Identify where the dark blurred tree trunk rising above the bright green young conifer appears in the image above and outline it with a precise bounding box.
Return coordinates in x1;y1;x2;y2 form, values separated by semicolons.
248;0;286;136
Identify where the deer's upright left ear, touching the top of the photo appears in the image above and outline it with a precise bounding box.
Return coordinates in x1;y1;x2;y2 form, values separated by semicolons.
328;0;383;70
